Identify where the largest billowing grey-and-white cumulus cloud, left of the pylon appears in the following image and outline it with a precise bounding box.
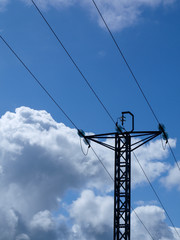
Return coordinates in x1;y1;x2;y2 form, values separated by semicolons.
0;107;113;240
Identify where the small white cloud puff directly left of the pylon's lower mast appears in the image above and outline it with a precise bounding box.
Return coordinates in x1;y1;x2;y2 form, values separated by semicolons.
70;190;113;239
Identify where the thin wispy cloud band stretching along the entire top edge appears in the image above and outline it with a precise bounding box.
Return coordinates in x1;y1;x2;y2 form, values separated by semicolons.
0;0;176;31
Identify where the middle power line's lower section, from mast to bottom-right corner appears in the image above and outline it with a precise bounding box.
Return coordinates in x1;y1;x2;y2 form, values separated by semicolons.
133;152;180;238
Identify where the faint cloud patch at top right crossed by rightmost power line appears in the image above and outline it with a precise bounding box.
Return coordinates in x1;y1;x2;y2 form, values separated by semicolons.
81;0;175;31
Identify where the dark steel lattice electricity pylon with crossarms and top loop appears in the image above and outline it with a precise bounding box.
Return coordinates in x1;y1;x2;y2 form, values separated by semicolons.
83;112;164;240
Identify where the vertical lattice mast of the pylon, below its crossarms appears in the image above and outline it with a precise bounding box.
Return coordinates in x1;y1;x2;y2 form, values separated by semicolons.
114;133;131;240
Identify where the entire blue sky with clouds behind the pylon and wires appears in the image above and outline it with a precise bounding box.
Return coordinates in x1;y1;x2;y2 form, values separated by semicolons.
0;0;180;240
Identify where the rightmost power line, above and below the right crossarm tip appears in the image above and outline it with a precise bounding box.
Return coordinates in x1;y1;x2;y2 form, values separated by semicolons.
91;0;180;171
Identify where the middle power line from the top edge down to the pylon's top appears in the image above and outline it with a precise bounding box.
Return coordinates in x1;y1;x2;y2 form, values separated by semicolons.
31;0;115;124
